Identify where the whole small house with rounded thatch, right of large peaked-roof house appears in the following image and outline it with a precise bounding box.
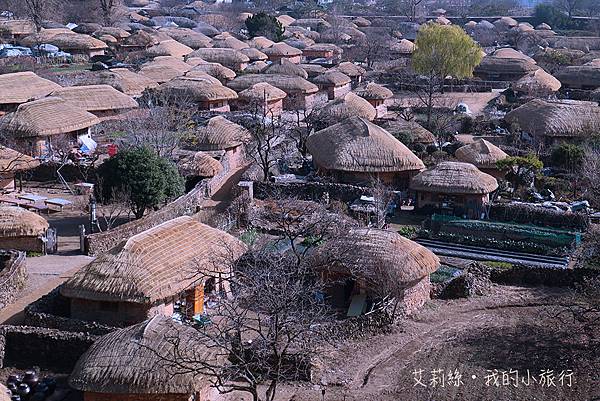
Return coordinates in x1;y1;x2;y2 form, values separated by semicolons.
410;162;498;219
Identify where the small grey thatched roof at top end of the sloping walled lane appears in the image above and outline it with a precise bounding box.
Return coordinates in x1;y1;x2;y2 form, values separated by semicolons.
198;116;250;150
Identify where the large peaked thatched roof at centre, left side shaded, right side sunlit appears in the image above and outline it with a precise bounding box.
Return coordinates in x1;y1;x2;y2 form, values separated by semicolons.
306;117;425;173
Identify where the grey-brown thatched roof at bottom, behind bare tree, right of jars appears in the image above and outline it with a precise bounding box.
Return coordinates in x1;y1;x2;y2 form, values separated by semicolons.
69;315;215;398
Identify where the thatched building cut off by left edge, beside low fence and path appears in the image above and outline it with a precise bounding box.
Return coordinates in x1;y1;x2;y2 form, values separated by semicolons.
0;206;49;253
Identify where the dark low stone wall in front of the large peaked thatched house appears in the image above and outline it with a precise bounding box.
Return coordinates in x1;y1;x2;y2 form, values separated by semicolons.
254;181;369;202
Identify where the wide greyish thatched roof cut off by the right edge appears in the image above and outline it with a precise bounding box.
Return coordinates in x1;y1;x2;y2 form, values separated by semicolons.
505;99;600;137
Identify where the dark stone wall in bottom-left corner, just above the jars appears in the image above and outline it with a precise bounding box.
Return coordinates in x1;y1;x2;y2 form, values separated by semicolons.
0;326;97;373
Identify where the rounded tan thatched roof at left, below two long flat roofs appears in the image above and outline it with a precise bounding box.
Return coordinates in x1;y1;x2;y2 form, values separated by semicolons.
4;97;100;137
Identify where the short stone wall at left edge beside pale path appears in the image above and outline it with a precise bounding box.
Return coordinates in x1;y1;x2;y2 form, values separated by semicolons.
0;251;27;309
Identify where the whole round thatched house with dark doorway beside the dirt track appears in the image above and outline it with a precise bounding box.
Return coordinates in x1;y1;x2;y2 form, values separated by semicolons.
316;228;440;317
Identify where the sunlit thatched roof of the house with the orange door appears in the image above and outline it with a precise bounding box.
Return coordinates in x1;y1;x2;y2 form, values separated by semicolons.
60;216;246;304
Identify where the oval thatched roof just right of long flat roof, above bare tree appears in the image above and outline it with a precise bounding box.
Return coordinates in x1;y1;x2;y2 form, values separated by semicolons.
158;76;238;102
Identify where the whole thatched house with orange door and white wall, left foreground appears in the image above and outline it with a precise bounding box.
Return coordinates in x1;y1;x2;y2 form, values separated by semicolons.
60;216;246;326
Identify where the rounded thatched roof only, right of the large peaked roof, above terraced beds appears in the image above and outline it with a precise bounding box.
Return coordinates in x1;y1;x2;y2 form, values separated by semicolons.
410;162;498;194
